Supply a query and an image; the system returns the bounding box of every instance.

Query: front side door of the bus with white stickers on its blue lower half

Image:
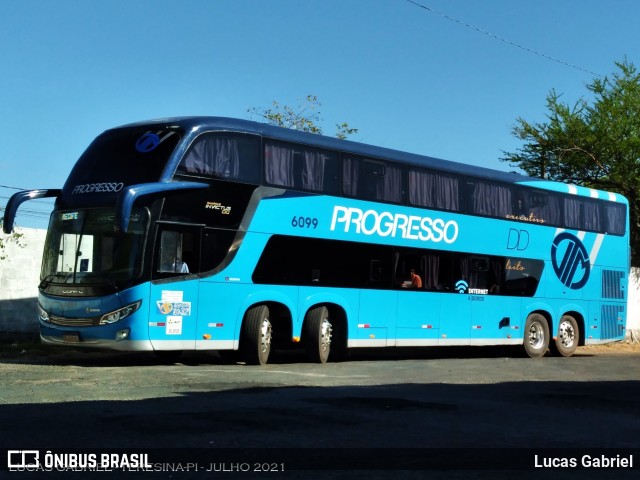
[149,224,201,350]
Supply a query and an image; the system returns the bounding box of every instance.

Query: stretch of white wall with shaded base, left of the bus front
[0,228,46,338]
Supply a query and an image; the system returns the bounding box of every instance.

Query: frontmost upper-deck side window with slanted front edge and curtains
[178,133,260,183]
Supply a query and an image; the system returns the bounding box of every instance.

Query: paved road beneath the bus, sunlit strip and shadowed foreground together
[0,348,640,480]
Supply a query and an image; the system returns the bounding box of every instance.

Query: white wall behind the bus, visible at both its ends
[0,228,640,340]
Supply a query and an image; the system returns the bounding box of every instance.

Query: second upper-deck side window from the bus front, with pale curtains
[264,140,338,194]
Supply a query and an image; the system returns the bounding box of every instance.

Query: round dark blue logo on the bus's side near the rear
[551,232,591,290]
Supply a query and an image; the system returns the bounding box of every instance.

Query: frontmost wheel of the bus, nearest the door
[240,305,273,365]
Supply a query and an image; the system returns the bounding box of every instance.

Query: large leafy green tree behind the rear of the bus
[502,60,640,266]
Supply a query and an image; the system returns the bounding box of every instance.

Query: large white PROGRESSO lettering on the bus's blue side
[331,206,458,243]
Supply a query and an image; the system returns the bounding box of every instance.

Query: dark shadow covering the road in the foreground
[0,381,640,458]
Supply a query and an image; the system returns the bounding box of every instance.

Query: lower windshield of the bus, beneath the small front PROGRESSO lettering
[41,208,149,290]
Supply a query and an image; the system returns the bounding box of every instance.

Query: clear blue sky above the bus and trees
[0,0,640,228]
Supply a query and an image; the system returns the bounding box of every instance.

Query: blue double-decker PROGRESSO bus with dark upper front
[4,117,630,364]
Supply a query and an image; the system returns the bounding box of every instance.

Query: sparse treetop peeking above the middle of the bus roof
[247,95,358,140]
